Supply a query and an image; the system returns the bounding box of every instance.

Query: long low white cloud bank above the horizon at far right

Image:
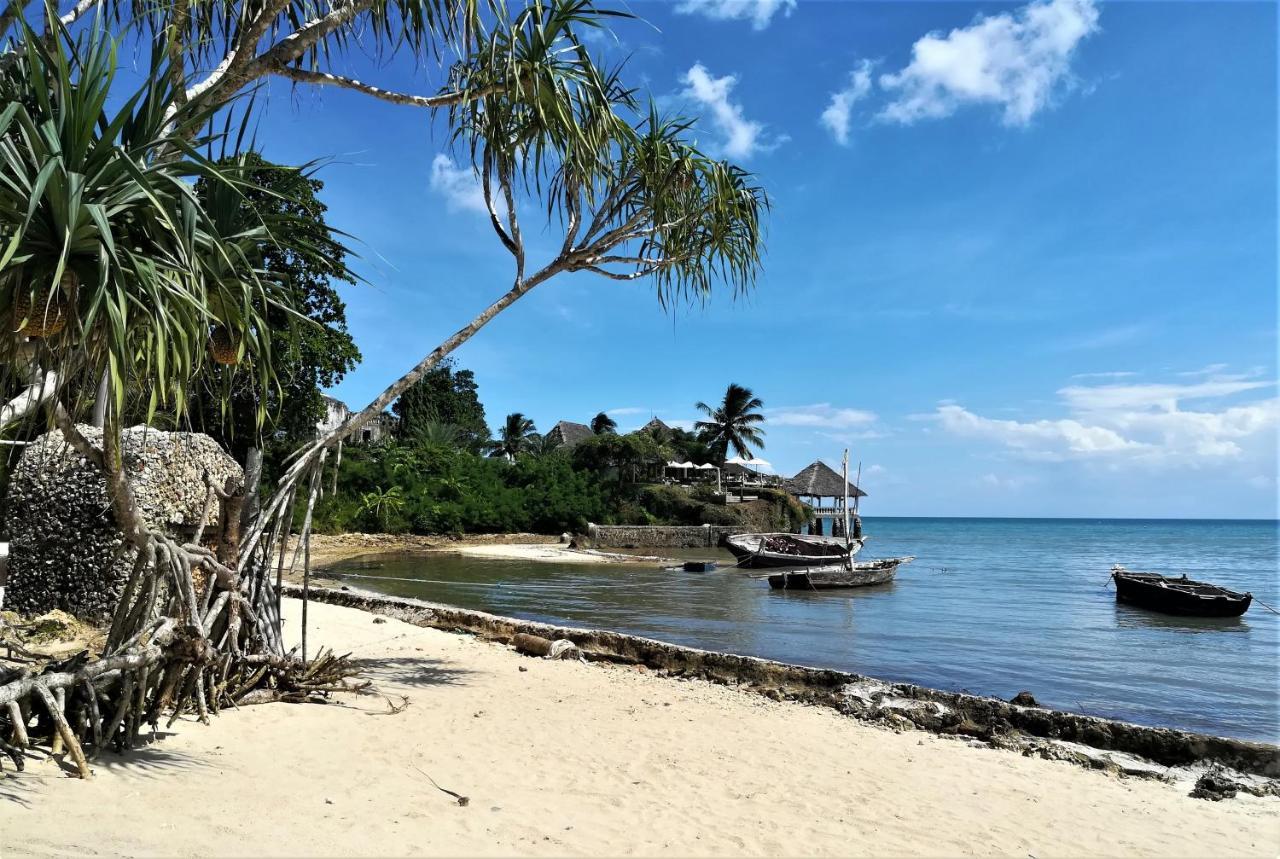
[932,368,1280,466]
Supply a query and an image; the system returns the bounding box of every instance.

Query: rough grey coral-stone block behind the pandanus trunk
[5,426,244,621]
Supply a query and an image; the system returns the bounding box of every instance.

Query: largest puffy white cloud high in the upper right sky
[879,0,1098,125]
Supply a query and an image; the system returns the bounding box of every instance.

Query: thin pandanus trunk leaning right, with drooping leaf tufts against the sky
[253,32,768,604]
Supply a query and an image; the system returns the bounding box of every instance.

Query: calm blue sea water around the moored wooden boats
[322,517,1280,743]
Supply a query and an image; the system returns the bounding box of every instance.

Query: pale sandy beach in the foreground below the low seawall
[0,600,1280,859]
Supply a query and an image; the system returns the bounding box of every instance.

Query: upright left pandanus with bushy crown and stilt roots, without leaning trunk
[0,22,355,775]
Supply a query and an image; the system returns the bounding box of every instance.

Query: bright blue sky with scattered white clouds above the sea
[235,0,1280,518]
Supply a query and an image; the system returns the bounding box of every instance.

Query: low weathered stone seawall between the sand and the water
[287,586,1280,799]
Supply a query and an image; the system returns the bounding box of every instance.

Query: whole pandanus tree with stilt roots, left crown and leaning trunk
[0,0,767,773]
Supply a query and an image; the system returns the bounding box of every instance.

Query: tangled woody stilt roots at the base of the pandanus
[0,406,369,777]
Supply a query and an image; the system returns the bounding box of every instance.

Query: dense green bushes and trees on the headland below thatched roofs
[315,378,806,534]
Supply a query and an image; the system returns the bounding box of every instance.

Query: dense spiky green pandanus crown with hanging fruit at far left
[0,24,302,430]
